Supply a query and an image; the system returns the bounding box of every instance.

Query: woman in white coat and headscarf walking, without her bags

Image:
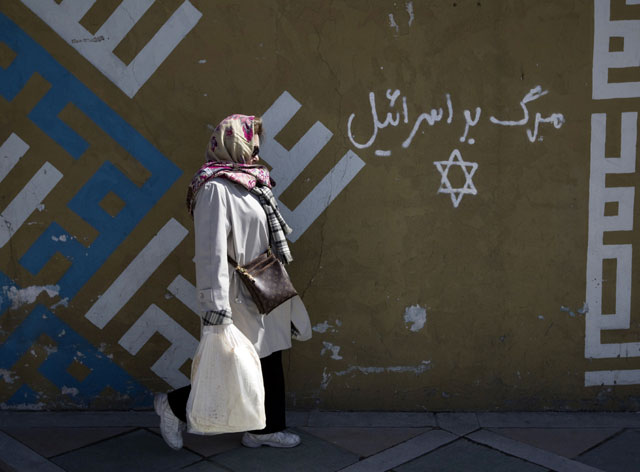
[154,115,311,449]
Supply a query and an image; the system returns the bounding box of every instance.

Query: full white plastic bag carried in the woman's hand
[187,324,266,434]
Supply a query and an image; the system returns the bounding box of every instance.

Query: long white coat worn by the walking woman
[193,178,311,358]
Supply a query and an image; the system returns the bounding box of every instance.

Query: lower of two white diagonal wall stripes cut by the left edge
[0,162,62,247]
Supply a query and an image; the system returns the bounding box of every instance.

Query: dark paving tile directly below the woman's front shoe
[210,430,358,472]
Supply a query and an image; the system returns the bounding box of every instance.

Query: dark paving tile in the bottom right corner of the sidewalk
[576,431,640,472]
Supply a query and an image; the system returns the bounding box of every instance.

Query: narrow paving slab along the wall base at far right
[476,412,640,428]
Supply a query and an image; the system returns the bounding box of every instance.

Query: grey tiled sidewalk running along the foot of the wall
[0,411,640,472]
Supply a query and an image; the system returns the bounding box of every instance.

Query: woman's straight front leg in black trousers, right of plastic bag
[251,351,287,434]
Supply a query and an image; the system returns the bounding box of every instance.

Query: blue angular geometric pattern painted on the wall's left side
[0,14,182,406]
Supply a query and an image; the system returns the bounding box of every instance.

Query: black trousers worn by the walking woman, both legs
[167,351,287,434]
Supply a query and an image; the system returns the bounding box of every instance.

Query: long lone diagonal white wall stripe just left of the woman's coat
[84,218,188,329]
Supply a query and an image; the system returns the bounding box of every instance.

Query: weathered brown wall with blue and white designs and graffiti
[0,0,640,410]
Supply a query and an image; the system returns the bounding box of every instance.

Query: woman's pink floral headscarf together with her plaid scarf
[187,115,293,264]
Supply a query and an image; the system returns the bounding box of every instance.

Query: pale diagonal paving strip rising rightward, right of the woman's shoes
[341,430,458,472]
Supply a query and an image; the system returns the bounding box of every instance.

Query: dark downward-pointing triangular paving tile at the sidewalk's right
[491,428,620,458]
